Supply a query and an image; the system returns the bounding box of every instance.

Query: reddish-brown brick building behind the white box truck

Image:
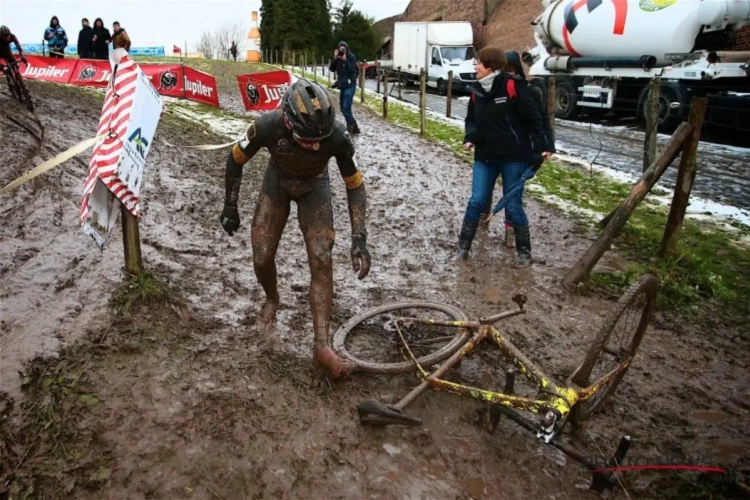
[376,0,750,55]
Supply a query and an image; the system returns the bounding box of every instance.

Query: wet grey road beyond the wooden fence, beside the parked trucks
[367,80,750,209]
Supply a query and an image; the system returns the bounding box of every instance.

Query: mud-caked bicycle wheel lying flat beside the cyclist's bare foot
[333,301,471,374]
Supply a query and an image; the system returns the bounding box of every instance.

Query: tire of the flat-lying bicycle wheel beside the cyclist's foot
[333,300,471,374]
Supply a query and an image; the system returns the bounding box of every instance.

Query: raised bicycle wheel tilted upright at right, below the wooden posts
[570,274,658,426]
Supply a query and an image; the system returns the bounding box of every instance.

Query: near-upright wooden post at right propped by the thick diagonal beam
[659,97,708,257]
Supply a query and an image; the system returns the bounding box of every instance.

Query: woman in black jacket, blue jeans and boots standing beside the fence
[457,47,550,267]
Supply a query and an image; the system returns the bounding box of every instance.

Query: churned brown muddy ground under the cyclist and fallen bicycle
[0,67,750,499]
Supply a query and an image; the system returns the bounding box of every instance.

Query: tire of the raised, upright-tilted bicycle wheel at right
[570,274,659,427]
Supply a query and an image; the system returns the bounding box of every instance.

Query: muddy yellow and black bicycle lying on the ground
[333,274,658,491]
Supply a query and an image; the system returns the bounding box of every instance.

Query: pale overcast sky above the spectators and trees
[0,0,409,52]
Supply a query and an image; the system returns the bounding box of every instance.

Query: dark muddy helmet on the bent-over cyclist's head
[282,78,336,141]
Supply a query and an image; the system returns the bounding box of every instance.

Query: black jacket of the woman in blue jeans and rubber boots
[464,73,547,164]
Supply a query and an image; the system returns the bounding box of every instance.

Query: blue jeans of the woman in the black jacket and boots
[464,160,529,227]
